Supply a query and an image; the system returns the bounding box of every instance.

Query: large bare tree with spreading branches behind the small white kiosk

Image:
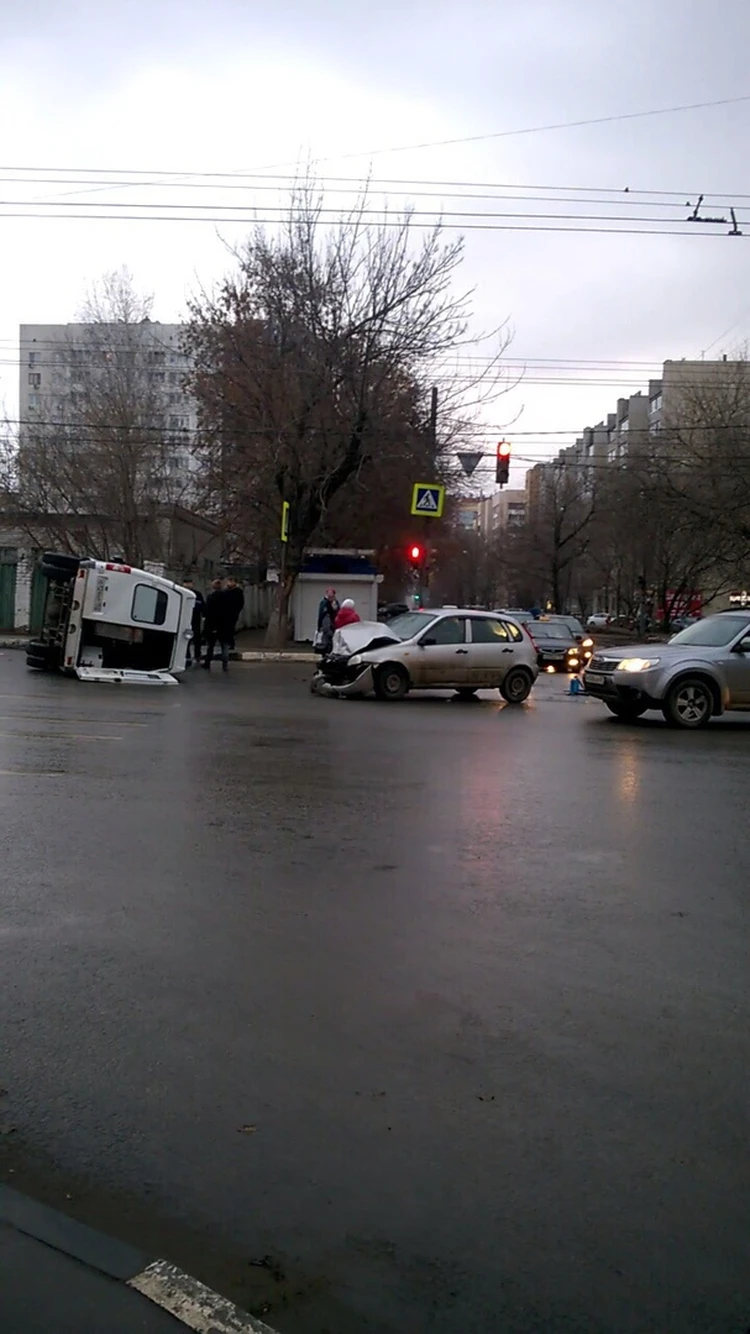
[187,184,507,638]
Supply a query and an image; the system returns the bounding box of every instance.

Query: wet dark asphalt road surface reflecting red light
[0,652,750,1334]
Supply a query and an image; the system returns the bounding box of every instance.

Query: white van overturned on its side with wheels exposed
[27,551,195,686]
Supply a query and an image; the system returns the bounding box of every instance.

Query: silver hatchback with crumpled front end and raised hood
[311,607,539,704]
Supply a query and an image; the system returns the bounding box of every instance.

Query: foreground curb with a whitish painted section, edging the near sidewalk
[0,1186,276,1334]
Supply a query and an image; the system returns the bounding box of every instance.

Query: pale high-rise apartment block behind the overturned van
[19,320,198,500]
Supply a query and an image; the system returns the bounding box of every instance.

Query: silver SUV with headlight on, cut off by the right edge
[583,611,750,727]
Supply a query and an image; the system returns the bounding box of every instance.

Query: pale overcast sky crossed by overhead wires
[0,0,750,480]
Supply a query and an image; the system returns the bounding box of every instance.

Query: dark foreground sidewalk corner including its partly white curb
[0,1186,274,1334]
